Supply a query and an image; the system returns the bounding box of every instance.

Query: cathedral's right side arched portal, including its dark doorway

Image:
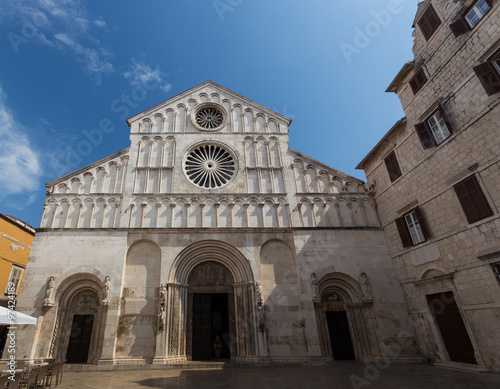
[314,273,377,360]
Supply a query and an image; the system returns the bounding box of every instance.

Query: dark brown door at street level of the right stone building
[426,292,477,365]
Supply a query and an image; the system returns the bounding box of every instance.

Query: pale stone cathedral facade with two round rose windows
[13,81,421,365]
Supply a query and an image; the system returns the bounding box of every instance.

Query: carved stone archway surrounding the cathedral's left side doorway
[49,274,107,364]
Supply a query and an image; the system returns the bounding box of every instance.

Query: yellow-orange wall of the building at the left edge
[0,215,35,306]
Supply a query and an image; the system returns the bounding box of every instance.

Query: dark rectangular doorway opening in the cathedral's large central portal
[192,293,230,361]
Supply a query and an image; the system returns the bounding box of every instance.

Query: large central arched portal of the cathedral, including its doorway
[166,240,259,362]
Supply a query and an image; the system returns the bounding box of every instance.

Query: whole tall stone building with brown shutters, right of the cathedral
[358,0,500,371]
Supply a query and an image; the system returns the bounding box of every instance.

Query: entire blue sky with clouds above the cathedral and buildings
[0,0,417,227]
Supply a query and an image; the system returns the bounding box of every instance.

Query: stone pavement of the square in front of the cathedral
[54,362,500,389]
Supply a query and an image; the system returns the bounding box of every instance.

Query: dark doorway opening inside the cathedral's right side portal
[326,311,355,360]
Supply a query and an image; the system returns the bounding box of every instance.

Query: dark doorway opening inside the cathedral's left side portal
[66,315,94,363]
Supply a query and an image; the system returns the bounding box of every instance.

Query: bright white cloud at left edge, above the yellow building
[0,87,42,197]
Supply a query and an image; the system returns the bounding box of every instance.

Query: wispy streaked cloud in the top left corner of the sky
[0,0,113,83]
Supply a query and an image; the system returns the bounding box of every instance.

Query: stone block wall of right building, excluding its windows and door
[363,1,500,371]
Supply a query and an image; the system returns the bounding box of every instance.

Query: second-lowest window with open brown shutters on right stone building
[415,105,452,150]
